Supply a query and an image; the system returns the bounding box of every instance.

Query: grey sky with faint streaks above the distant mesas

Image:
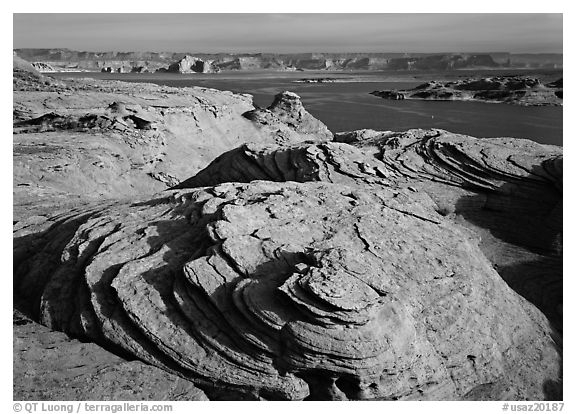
[13,13,563,53]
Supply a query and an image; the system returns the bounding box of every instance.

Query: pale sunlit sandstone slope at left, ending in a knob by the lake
[13,62,331,217]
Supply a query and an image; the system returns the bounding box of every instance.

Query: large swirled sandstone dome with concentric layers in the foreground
[14,181,560,399]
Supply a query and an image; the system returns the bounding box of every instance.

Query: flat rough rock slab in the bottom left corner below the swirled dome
[13,311,208,401]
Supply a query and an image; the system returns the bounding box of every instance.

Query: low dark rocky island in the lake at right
[371,76,562,105]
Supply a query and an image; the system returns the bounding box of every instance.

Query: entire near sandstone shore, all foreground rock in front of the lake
[13,53,563,400]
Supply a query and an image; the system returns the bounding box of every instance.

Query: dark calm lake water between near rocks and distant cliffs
[56,71,563,145]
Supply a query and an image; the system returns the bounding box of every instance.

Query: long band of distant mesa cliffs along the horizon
[15,49,563,73]
